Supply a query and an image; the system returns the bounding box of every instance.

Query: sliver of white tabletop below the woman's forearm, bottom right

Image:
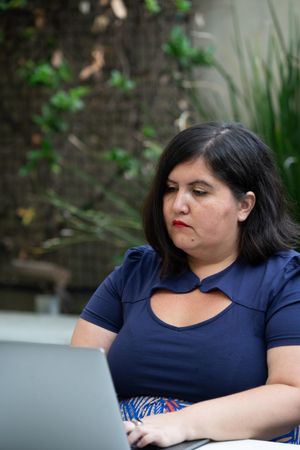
[206,439,298,450]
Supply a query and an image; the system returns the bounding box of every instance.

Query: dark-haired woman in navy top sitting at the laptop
[72,122,300,447]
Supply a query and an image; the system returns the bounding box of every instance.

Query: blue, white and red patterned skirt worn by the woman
[119,396,300,445]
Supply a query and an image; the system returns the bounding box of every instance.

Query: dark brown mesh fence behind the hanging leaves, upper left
[0,0,187,306]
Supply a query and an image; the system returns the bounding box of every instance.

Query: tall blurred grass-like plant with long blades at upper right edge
[239,2,300,211]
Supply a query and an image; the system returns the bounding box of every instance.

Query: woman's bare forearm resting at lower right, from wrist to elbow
[178,384,300,441]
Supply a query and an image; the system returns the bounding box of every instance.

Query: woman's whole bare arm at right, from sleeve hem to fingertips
[127,346,300,447]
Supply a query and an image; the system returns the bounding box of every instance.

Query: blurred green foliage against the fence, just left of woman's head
[43,125,162,252]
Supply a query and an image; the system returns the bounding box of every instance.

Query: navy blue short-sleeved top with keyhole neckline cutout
[81,246,300,402]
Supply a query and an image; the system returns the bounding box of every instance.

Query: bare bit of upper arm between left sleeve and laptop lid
[71,319,117,353]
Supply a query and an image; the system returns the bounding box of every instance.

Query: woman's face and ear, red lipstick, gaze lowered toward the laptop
[163,158,255,261]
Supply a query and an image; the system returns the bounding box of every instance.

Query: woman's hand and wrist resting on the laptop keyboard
[124,411,186,448]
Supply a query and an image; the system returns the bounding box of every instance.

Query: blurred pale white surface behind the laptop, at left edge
[0,311,78,344]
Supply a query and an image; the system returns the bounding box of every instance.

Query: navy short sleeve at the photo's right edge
[266,256,300,349]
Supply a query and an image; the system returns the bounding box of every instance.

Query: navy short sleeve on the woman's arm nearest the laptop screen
[80,246,148,333]
